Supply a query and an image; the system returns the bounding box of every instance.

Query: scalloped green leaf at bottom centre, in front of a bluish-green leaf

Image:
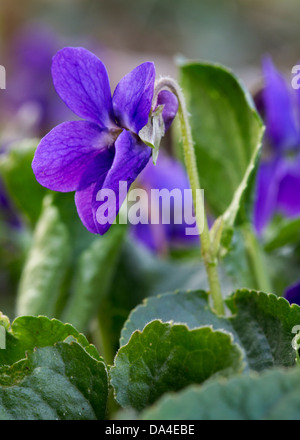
[110,320,243,410]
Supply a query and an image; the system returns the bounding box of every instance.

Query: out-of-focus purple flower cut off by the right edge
[254,58,300,234]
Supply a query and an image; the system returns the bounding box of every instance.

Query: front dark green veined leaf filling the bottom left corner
[0,342,108,420]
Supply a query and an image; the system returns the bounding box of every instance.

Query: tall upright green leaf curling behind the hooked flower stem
[180,62,263,248]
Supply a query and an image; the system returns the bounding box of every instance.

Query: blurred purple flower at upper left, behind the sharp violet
[3,25,71,140]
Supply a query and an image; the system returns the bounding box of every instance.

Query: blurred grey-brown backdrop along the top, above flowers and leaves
[0,0,300,88]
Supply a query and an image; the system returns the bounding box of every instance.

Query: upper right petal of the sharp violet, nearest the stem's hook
[113,62,155,134]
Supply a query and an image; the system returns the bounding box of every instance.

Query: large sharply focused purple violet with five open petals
[32,47,177,234]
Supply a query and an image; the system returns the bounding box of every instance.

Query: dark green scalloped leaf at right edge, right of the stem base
[227,289,300,371]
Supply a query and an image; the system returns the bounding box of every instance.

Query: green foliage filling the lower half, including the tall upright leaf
[0,56,300,420]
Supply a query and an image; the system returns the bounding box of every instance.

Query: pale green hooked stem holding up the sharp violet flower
[153,78,225,315]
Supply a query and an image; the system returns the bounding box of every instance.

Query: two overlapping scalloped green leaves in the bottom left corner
[0,316,108,420]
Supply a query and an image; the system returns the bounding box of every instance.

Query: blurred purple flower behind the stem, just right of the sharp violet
[131,152,199,254]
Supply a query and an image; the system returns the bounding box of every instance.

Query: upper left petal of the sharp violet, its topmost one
[52,47,115,128]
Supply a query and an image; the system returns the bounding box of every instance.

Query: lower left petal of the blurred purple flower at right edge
[253,159,282,235]
